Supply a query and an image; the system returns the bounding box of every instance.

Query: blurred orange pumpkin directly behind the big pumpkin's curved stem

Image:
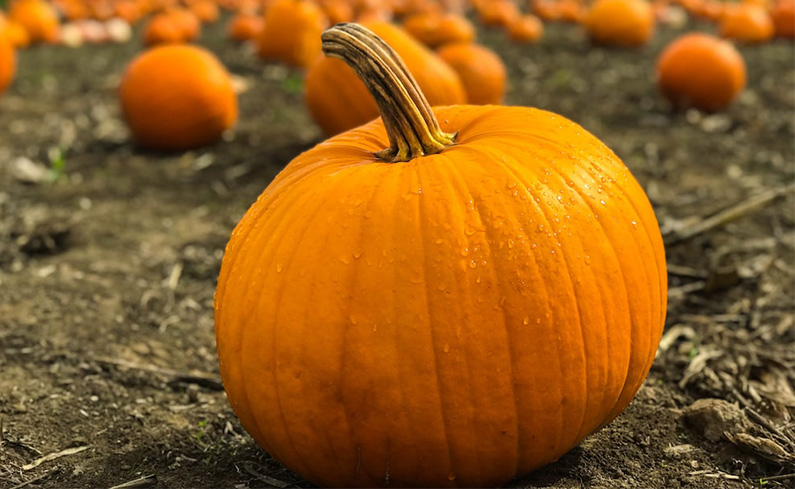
[305,21,466,135]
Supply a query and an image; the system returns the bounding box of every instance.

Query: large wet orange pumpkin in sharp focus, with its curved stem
[215,24,667,487]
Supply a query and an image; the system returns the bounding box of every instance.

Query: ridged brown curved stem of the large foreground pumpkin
[321,24,457,163]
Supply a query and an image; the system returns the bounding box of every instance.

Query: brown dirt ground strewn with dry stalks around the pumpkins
[0,14,795,489]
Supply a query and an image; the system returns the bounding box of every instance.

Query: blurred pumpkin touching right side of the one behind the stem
[436,43,508,105]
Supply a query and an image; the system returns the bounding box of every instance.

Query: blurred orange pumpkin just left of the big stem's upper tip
[258,0,327,67]
